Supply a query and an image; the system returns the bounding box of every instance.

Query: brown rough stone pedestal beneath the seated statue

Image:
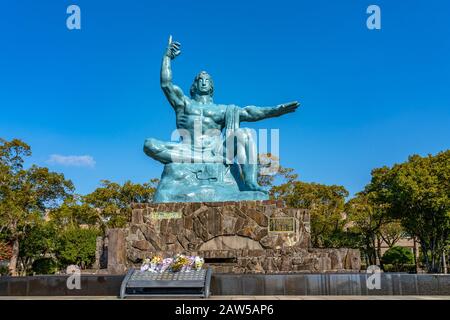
[121,200,360,273]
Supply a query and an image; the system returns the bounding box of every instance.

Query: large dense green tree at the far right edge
[366,150,450,272]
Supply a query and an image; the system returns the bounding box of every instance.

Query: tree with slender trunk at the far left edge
[0,139,73,275]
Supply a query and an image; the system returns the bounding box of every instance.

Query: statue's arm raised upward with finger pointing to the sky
[161,36,186,109]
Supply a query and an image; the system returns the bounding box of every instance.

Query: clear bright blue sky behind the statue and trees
[0,0,450,194]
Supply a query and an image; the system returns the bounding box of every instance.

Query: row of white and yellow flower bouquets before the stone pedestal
[141,254,205,272]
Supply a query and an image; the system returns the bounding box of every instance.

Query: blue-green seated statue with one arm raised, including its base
[144,37,299,203]
